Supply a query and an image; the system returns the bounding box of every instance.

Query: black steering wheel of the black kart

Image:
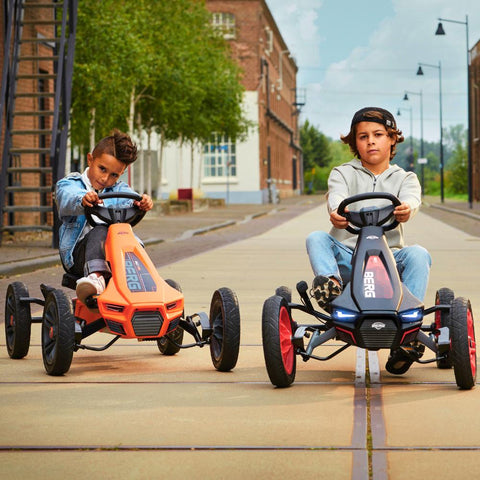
[337,192,402,235]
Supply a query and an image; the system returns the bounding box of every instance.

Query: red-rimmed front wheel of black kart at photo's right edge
[450,297,477,390]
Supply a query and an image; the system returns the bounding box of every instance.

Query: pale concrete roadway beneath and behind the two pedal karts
[0,199,480,480]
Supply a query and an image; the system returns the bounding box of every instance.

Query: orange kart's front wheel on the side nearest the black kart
[209,287,240,372]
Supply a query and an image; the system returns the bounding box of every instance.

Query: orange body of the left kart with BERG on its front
[75,223,184,340]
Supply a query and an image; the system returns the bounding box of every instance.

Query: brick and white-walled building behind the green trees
[140,0,303,203]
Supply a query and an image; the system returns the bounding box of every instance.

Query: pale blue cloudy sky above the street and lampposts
[266,0,480,142]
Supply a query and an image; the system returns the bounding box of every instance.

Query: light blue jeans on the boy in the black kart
[307,231,432,301]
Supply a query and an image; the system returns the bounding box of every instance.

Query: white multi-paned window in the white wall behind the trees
[203,134,237,178]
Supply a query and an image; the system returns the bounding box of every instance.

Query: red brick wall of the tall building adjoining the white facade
[206,0,301,196]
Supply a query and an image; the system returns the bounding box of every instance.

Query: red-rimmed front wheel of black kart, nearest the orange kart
[262,295,297,387]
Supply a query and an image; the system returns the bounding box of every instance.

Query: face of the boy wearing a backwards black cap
[355,122,395,174]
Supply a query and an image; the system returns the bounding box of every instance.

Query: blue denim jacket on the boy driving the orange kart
[55,172,133,270]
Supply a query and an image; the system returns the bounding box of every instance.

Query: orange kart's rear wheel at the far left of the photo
[5,282,32,358]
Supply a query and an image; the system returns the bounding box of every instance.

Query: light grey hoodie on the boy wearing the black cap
[327,159,422,250]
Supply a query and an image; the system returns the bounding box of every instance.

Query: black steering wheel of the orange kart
[85,192,147,227]
